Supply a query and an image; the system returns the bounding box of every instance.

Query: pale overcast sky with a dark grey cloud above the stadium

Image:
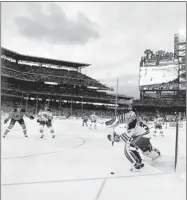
[1,2,186,98]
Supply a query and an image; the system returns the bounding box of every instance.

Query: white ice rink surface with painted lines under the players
[1,119,186,200]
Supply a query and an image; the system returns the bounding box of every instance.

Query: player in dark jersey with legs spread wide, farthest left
[3,105,34,138]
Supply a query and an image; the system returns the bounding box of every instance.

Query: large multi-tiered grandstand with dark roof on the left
[1,48,132,116]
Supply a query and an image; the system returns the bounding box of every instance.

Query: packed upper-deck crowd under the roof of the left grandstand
[1,59,107,88]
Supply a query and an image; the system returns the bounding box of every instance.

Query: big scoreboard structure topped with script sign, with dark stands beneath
[132,35,186,117]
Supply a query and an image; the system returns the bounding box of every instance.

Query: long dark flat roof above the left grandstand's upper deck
[1,47,91,69]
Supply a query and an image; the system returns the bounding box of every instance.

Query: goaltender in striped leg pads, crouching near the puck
[105,111,160,171]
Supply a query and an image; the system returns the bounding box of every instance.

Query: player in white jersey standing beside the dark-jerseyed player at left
[37,105,55,138]
